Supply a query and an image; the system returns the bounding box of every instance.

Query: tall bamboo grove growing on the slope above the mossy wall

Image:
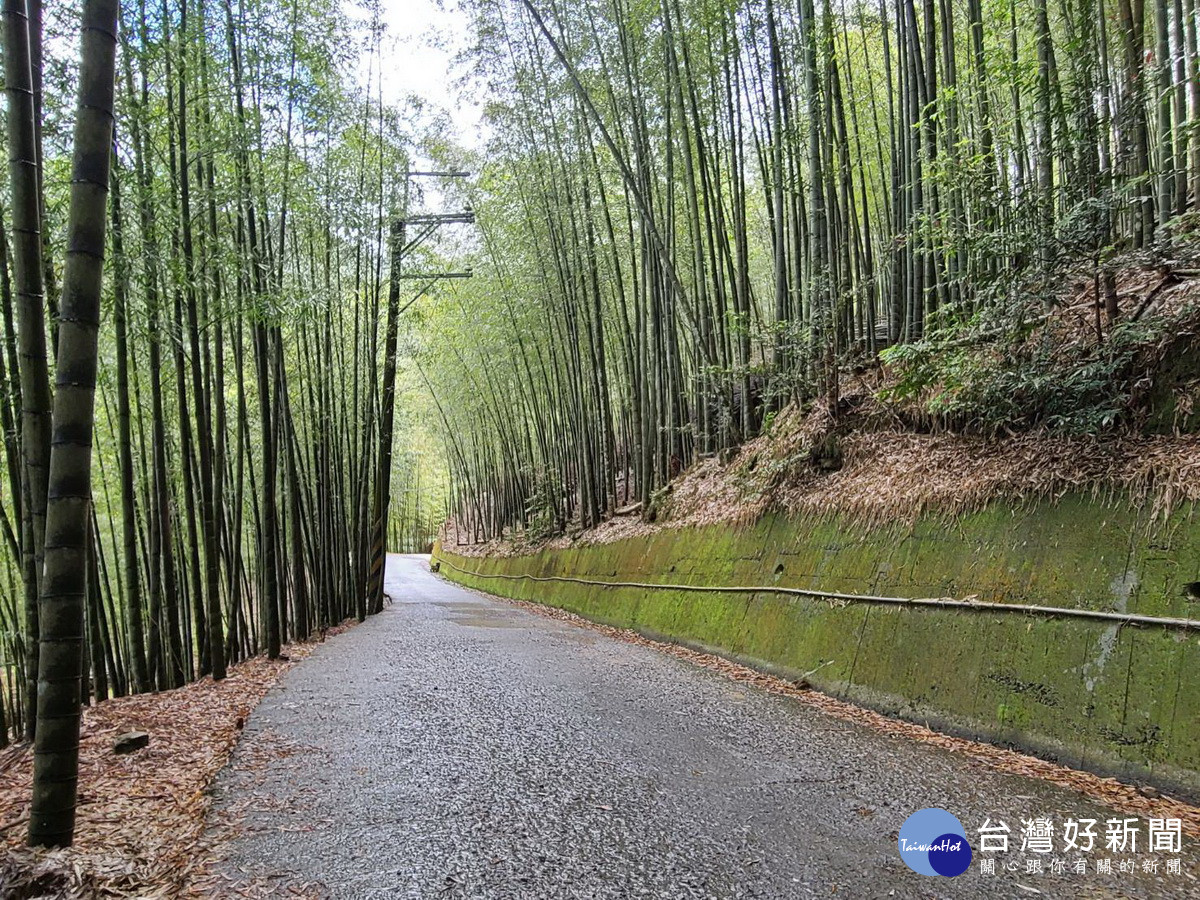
[422,0,1200,541]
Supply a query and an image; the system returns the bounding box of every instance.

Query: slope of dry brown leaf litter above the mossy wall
[443,260,1200,557]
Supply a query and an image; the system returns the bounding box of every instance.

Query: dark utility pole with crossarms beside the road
[367,170,475,612]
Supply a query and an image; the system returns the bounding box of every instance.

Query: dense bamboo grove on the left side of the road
[0,0,444,845]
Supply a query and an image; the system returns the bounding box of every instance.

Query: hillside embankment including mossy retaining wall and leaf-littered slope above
[434,267,1200,798]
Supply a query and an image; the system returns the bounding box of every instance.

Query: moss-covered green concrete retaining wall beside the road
[434,497,1200,796]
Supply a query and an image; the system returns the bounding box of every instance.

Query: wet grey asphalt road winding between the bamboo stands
[212,557,1200,899]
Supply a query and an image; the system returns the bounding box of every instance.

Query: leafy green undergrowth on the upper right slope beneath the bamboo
[876,262,1200,434]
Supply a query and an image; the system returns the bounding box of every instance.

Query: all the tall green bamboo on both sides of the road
[0,0,1200,845]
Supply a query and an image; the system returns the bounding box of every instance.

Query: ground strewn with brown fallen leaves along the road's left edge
[0,623,349,900]
